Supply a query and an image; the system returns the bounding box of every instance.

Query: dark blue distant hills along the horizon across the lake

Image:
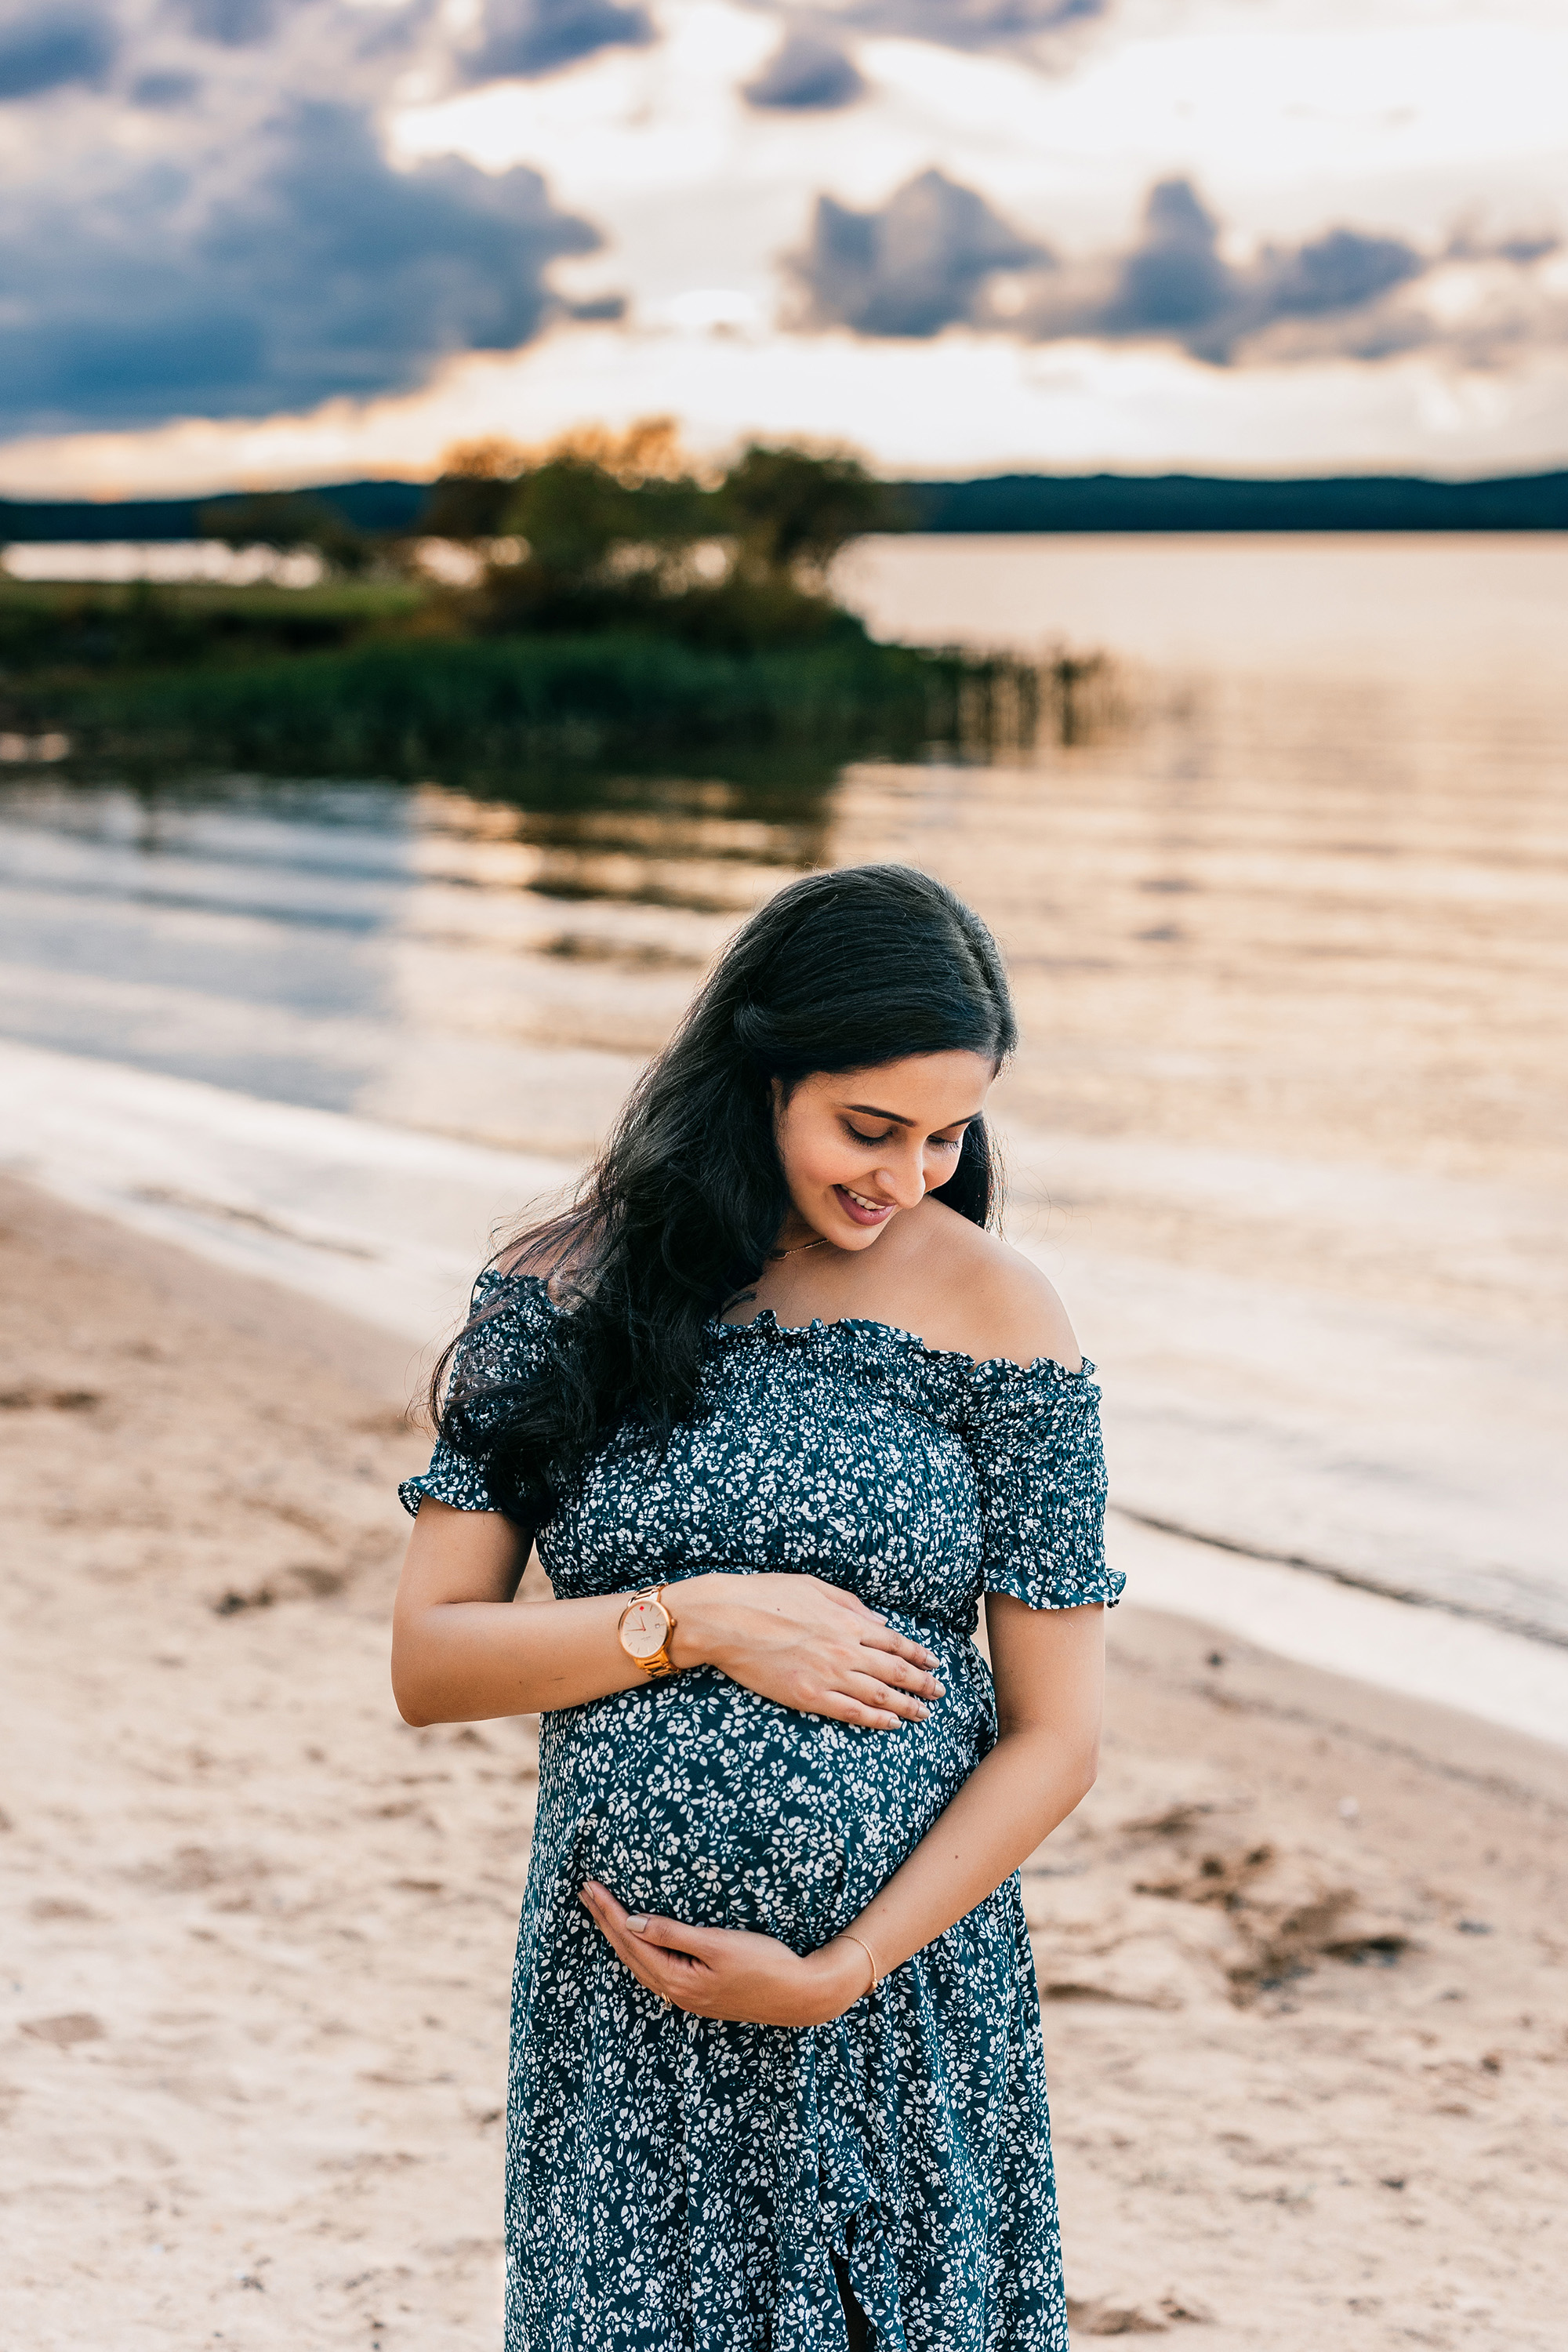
[0,473,1568,546]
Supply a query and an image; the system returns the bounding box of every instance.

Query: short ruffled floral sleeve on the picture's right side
[966,1357,1126,1609]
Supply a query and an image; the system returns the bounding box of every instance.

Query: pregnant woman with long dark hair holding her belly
[393,866,1119,2352]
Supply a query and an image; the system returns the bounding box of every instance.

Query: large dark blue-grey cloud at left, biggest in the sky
[0,103,600,433]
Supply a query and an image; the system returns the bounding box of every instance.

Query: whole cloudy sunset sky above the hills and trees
[0,0,1568,494]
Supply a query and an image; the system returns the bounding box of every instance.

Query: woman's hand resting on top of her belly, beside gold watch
[666,1571,942,1731]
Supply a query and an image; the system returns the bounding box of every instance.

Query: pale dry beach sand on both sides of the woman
[0,1185,1568,2352]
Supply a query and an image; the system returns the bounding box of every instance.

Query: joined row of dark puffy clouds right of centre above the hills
[789,172,1504,367]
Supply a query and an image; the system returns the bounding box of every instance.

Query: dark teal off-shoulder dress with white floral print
[405,1270,1121,2352]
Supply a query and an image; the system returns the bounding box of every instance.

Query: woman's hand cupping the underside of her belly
[583,1879,869,2027]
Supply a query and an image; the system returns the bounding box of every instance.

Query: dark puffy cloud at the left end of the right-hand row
[792,172,1048,334]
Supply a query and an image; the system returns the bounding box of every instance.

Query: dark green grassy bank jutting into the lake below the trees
[0,583,1034,774]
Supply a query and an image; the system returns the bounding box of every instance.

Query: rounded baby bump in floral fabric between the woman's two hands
[550,1637,989,1952]
